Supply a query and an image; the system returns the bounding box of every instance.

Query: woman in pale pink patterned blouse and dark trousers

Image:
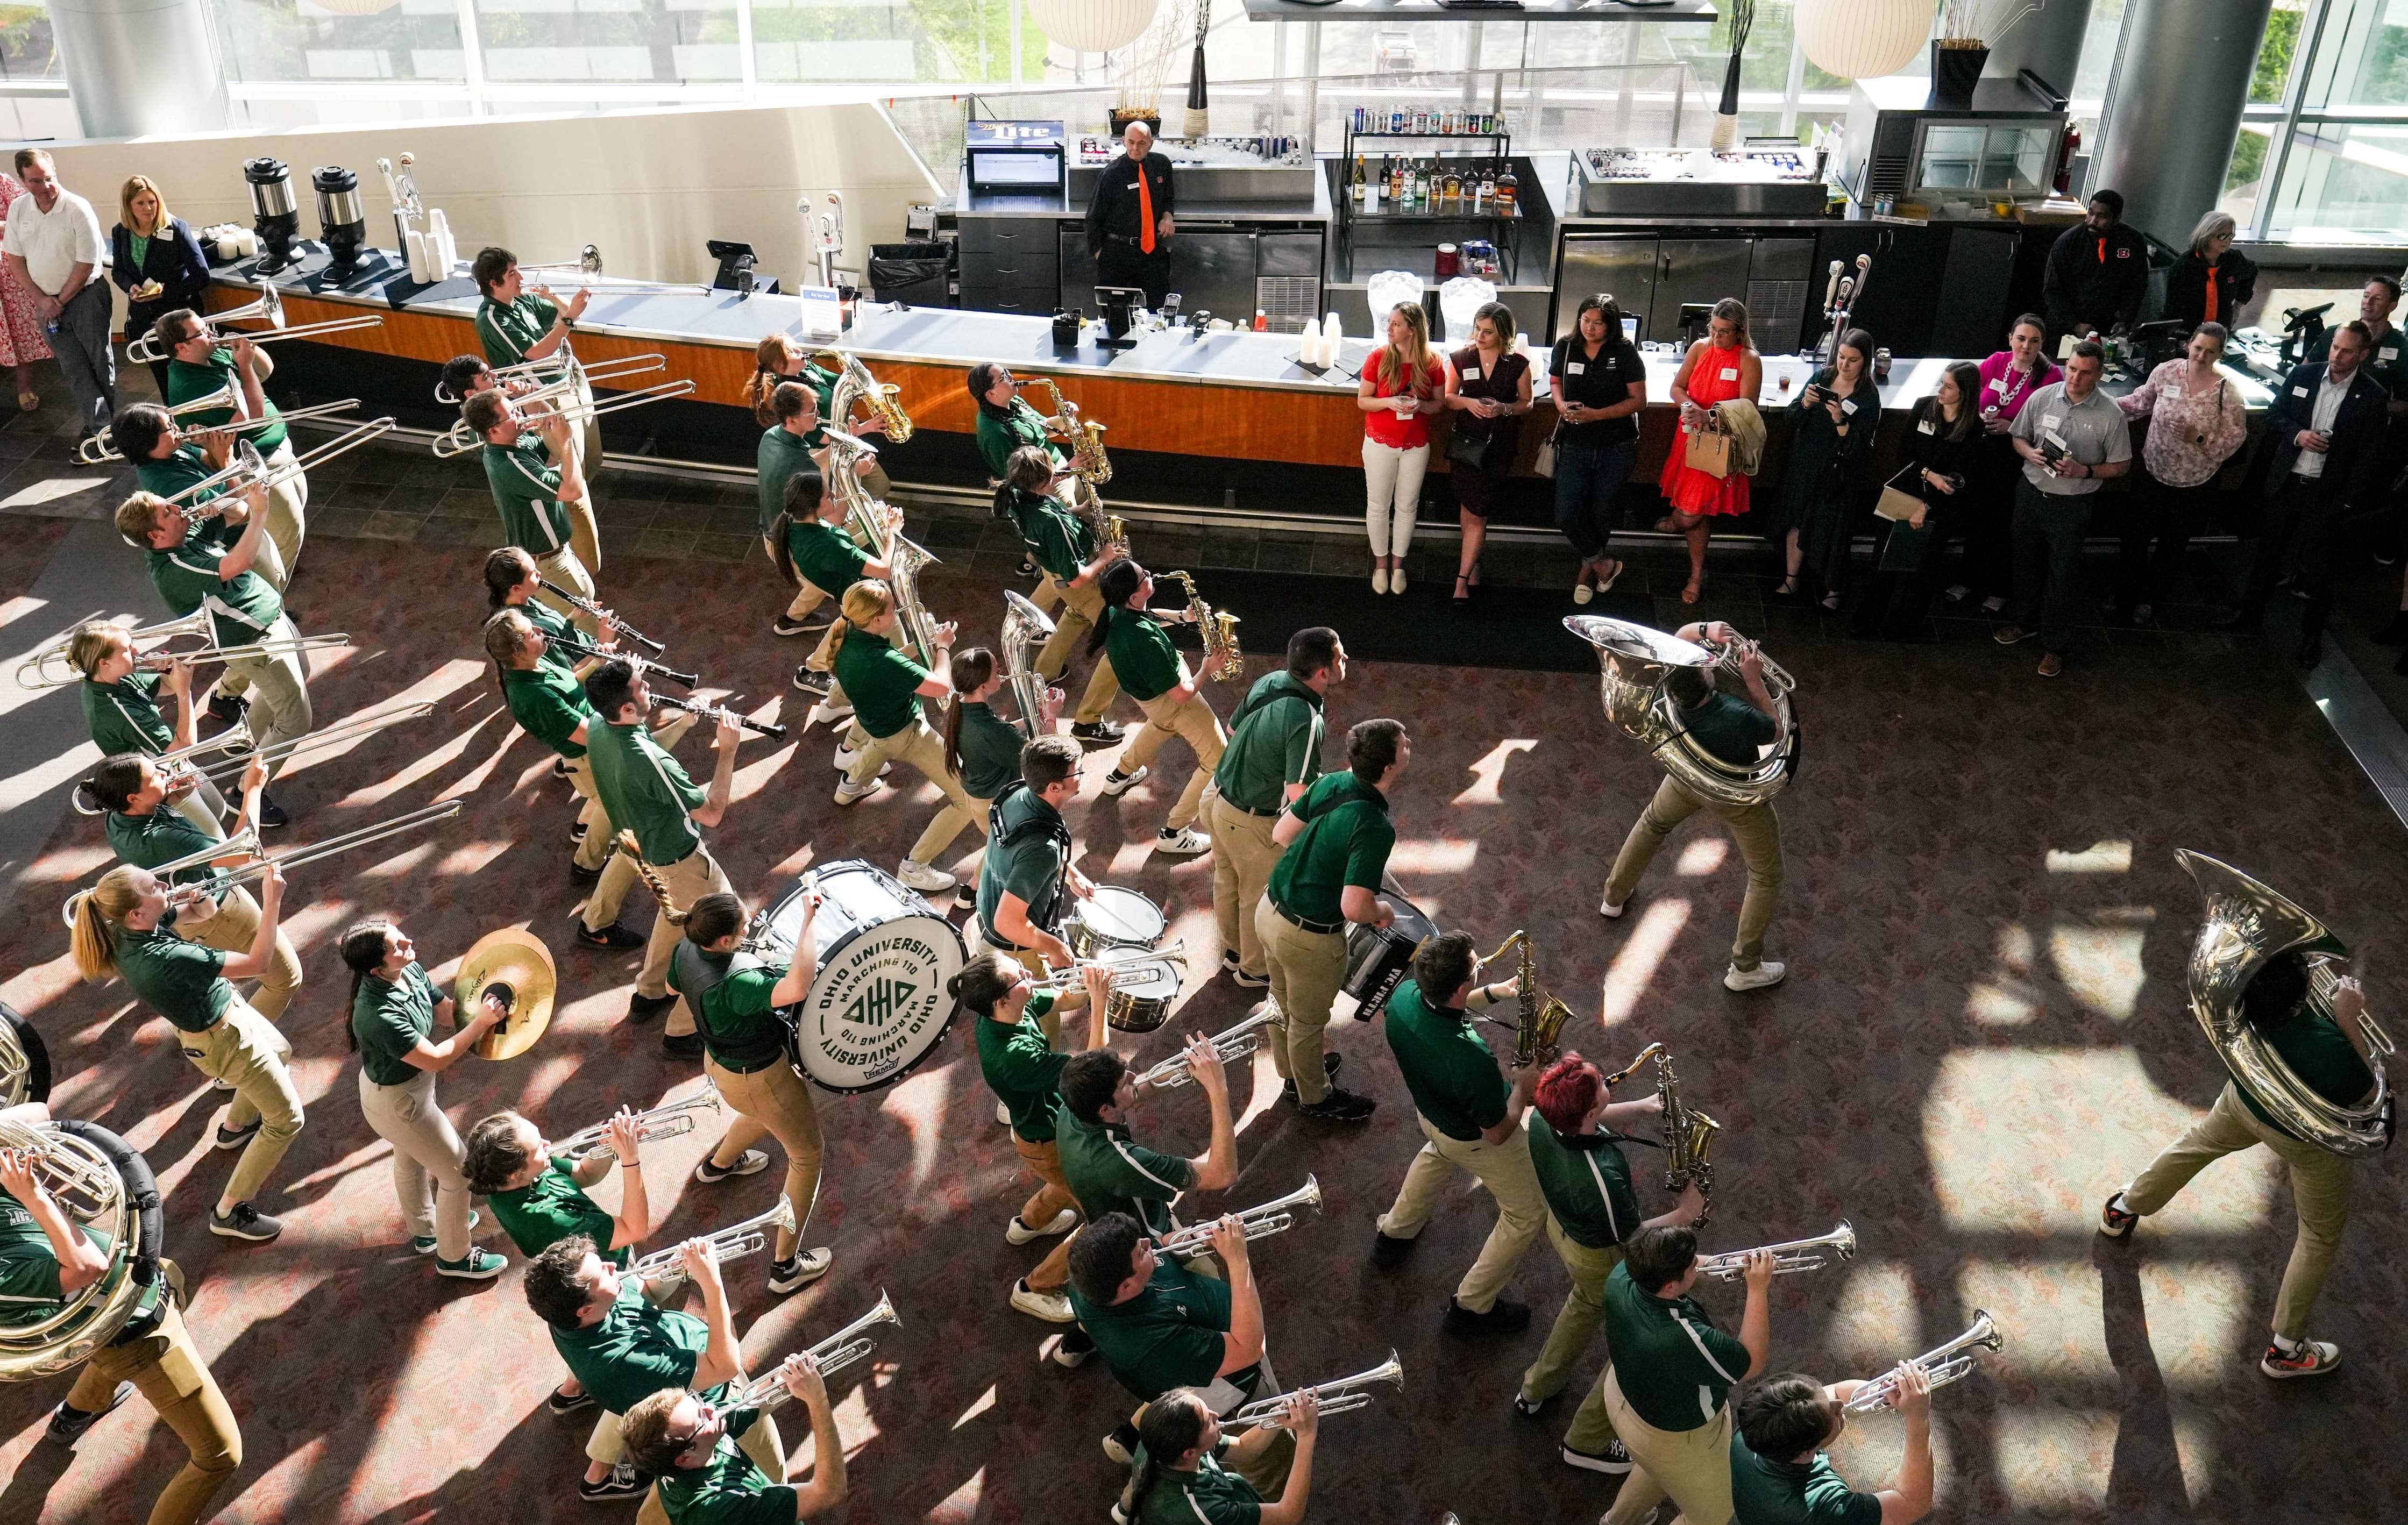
[2114,323,2249,624]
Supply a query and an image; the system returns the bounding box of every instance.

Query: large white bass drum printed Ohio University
[747,858,965,1092]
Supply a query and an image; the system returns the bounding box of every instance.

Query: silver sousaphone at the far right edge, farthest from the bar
[2175,848,2398,1159]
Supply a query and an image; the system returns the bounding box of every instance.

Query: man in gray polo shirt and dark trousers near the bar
[1991,340,2131,677]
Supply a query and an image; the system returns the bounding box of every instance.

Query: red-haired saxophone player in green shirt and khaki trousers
[1512,1053,1705,1472]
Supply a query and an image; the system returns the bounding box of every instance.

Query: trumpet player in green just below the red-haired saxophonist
[1572,1229,1775,1525]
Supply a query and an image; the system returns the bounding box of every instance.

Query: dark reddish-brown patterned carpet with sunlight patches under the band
[0,505,2408,1525]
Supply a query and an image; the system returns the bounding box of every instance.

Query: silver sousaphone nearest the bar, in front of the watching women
[1563,614,1799,804]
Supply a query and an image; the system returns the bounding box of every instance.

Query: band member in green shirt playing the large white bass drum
[670,892,833,1296]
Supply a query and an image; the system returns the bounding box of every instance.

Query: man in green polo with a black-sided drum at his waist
[1255,721,1413,1123]
